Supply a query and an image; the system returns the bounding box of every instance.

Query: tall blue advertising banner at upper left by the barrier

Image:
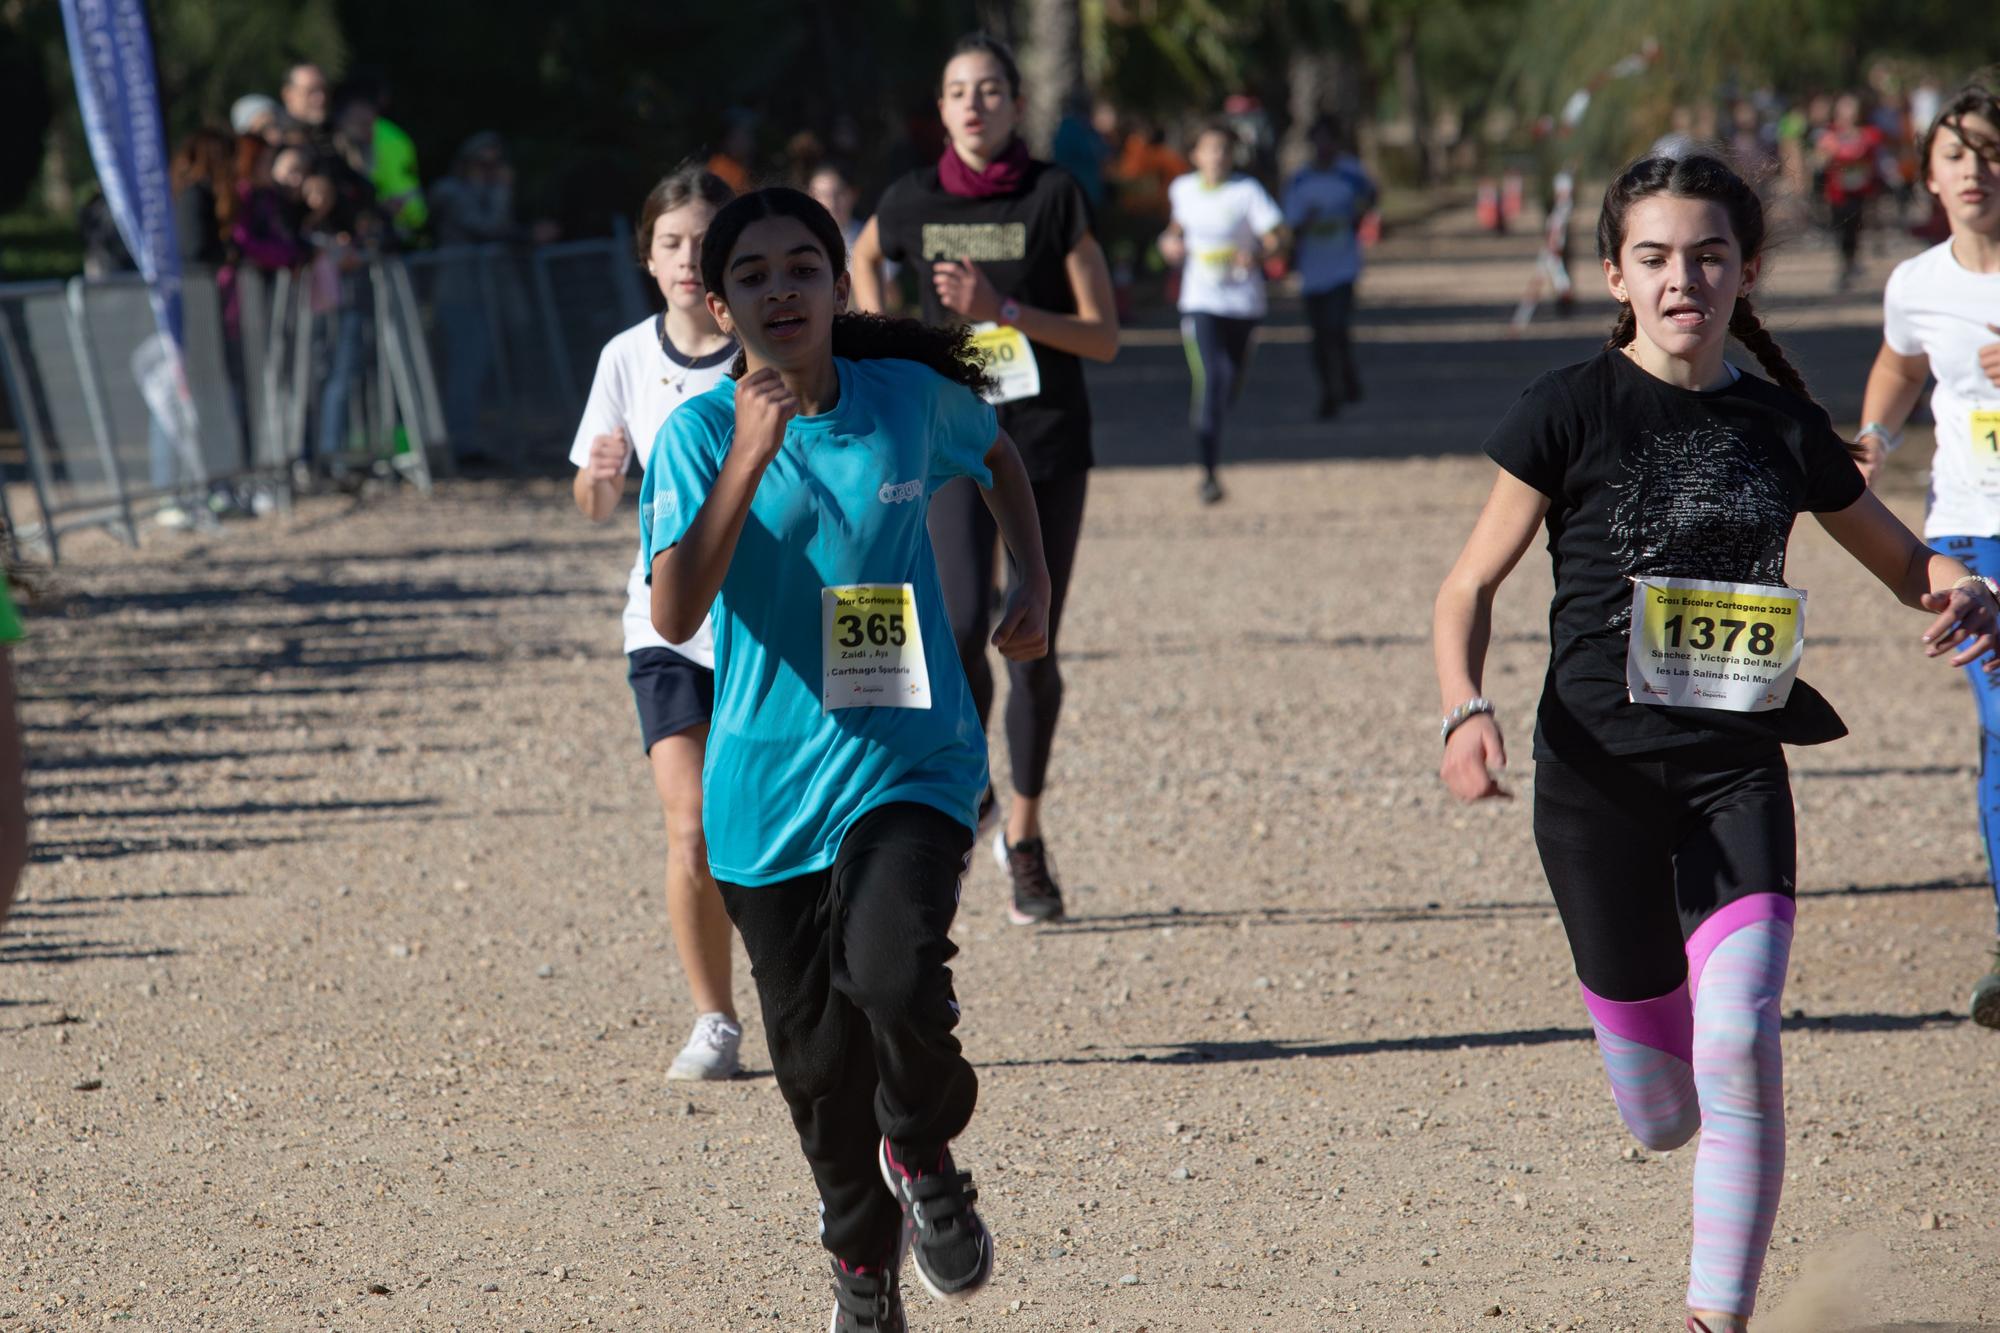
[62,0,182,352]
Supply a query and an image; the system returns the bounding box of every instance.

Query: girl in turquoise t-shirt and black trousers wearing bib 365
[640,190,1050,1333]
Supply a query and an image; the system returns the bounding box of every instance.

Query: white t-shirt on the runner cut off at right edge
[1882,240,2000,538]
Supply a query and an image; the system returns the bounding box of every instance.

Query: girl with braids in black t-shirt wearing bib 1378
[1434,156,2000,1333]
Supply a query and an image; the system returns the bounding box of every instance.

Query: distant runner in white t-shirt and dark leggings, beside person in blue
[1160,124,1284,504]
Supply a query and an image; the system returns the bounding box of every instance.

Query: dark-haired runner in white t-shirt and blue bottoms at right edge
[1856,84,2000,1029]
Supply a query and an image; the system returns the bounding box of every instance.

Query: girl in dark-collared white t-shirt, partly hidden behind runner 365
[570,166,742,1079]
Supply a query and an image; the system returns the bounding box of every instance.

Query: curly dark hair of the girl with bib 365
[702,186,992,394]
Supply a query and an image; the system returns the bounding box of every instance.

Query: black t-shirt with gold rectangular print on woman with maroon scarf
[876,162,1092,480]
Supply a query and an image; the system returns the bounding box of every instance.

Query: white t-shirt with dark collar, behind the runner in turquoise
[570,314,736,669]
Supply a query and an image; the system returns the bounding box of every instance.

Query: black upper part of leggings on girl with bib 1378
[1534,743,1798,1003]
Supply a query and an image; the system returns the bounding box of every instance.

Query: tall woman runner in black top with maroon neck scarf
[852,34,1118,925]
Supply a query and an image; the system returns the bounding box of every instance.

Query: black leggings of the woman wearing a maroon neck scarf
[930,472,1090,797]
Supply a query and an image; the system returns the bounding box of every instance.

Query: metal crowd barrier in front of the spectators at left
[0,232,648,560]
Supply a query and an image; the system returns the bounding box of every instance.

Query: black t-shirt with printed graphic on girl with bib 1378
[1486,350,1866,759]
